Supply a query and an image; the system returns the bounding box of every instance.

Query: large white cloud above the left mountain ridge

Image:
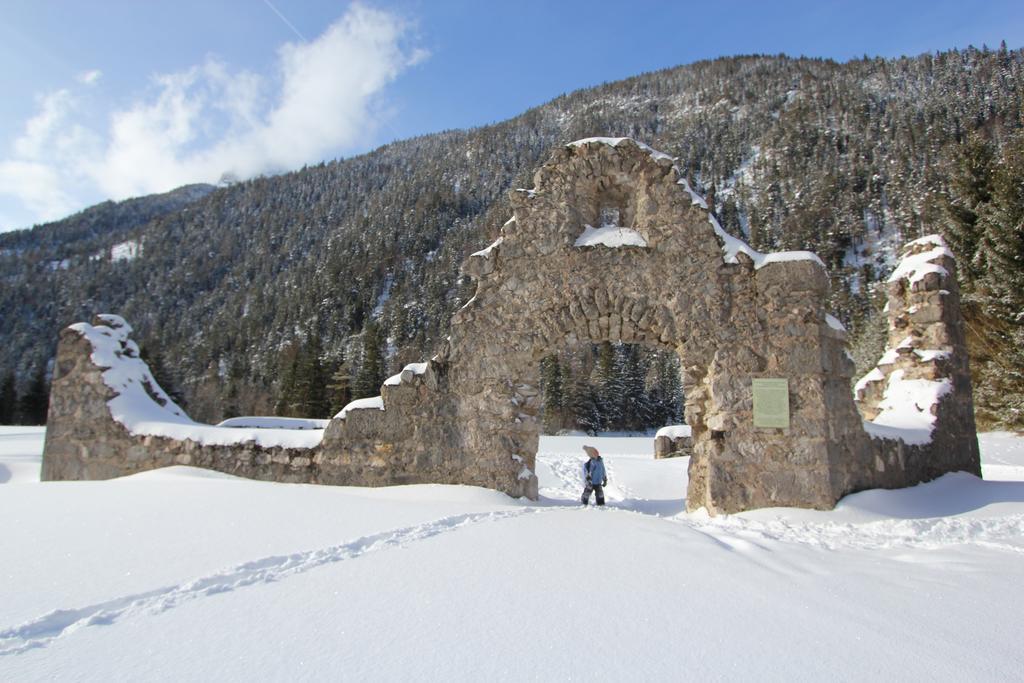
[0,4,426,229]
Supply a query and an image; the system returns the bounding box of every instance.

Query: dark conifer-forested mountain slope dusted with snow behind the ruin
[0,48,1024,420]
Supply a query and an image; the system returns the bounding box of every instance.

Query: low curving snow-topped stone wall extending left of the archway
[42,314,459,485]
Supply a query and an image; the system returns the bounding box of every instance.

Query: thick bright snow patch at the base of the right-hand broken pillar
[857,370,953,445]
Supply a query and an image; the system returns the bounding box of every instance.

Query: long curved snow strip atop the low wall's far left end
[71,313,324,449]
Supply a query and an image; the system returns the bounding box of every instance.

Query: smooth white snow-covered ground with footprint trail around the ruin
[0,427,1024,681]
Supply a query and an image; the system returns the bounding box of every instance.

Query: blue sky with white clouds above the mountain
[0,0,1024,230]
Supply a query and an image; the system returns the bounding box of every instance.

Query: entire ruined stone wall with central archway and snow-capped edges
[43,138,980,514]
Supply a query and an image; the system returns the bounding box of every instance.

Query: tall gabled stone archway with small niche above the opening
[446,139,860,510]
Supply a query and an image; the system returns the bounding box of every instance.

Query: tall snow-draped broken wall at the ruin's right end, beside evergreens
[854,234,981,485]
